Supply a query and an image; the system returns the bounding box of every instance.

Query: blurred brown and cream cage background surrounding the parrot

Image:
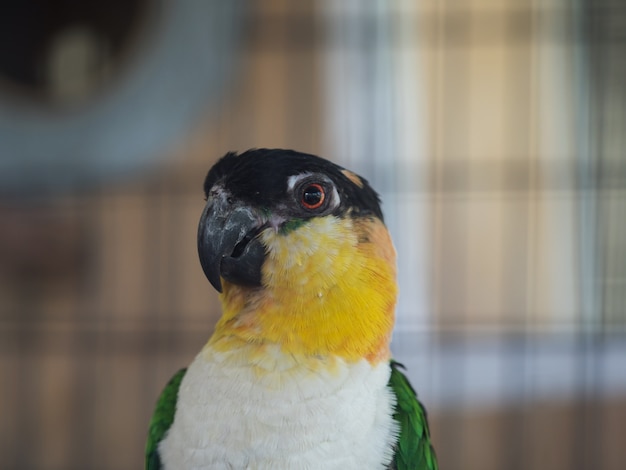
[0,0,626,470]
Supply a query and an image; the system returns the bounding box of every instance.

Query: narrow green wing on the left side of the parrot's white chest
[145,369,187,470]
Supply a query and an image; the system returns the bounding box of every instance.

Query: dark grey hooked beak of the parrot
[198,196,265,292]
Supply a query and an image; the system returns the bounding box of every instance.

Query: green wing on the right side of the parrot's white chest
[389,361,439,470]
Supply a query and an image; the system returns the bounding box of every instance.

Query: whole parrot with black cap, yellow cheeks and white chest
[145,148,438,470]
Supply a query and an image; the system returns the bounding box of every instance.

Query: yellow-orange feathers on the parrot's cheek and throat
[211,216,397,364]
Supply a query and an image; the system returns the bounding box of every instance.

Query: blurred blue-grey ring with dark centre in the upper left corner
[0,0,242,197]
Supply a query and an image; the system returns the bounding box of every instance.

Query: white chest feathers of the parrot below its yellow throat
[159,347,398,470]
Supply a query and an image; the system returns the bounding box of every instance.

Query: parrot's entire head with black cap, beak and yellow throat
[198,149,396,359]
